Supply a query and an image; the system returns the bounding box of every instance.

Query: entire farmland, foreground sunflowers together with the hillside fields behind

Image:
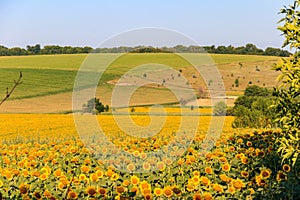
[0,53,299,199]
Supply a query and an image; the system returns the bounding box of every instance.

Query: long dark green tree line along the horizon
[0,44,291,57]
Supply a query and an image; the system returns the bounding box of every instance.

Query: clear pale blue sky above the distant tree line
[0,0,292,48]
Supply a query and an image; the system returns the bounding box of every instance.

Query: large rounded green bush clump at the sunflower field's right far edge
[232,86,274,128]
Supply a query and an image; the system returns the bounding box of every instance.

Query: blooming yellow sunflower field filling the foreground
[0,114,300,199]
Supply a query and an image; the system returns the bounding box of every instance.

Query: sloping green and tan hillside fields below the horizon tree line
[0,53,280,112]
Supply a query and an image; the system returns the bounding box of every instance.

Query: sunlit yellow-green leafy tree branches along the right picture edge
[272,0,300,165]
